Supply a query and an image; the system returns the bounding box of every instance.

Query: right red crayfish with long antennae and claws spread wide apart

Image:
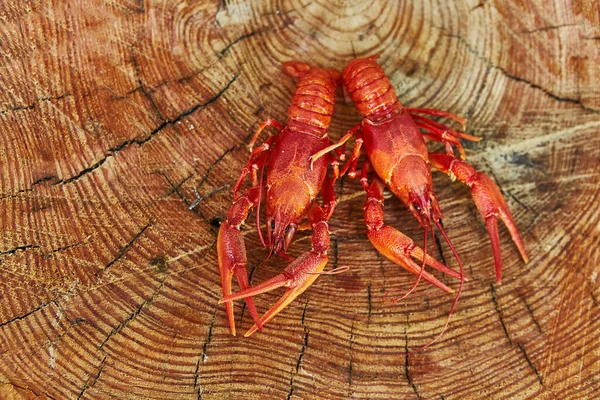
[311,56,527,345]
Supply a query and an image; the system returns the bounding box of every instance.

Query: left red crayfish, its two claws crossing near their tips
[217,61,341,336]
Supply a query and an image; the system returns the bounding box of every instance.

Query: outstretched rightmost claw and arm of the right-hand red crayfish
[429,153,529,283]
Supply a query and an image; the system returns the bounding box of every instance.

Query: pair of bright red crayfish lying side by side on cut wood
[217,57,527,345]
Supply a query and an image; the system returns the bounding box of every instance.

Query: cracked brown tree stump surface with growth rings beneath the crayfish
[0,0,600,399]
